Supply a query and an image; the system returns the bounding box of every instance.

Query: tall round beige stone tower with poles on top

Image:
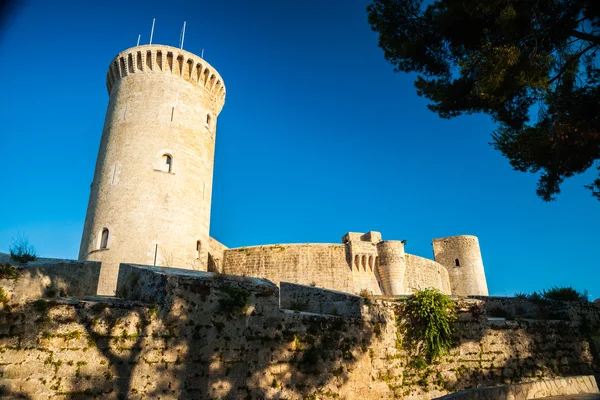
[79,45,225,295]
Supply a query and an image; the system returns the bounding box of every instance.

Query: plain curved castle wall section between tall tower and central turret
[223,244,355,293]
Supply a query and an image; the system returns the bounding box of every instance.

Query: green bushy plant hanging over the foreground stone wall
[404,289,456,361]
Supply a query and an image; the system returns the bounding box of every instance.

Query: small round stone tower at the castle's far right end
[432,235,488,296]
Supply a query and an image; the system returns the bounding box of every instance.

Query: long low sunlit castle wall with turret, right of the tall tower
[220,232,460,296]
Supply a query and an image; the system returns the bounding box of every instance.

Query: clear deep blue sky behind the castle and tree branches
[0,0,600,298]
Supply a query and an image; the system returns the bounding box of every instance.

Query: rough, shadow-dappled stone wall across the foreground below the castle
[0,258,600,399]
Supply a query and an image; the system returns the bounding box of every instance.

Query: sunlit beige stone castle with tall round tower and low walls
[79,45,488,296]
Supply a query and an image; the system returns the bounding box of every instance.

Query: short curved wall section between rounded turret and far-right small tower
[404,254,451,294]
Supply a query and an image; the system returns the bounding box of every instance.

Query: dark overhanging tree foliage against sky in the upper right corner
[367,0,600,201]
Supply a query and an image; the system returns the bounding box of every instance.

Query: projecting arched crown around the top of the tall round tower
[106,44,225,113]
